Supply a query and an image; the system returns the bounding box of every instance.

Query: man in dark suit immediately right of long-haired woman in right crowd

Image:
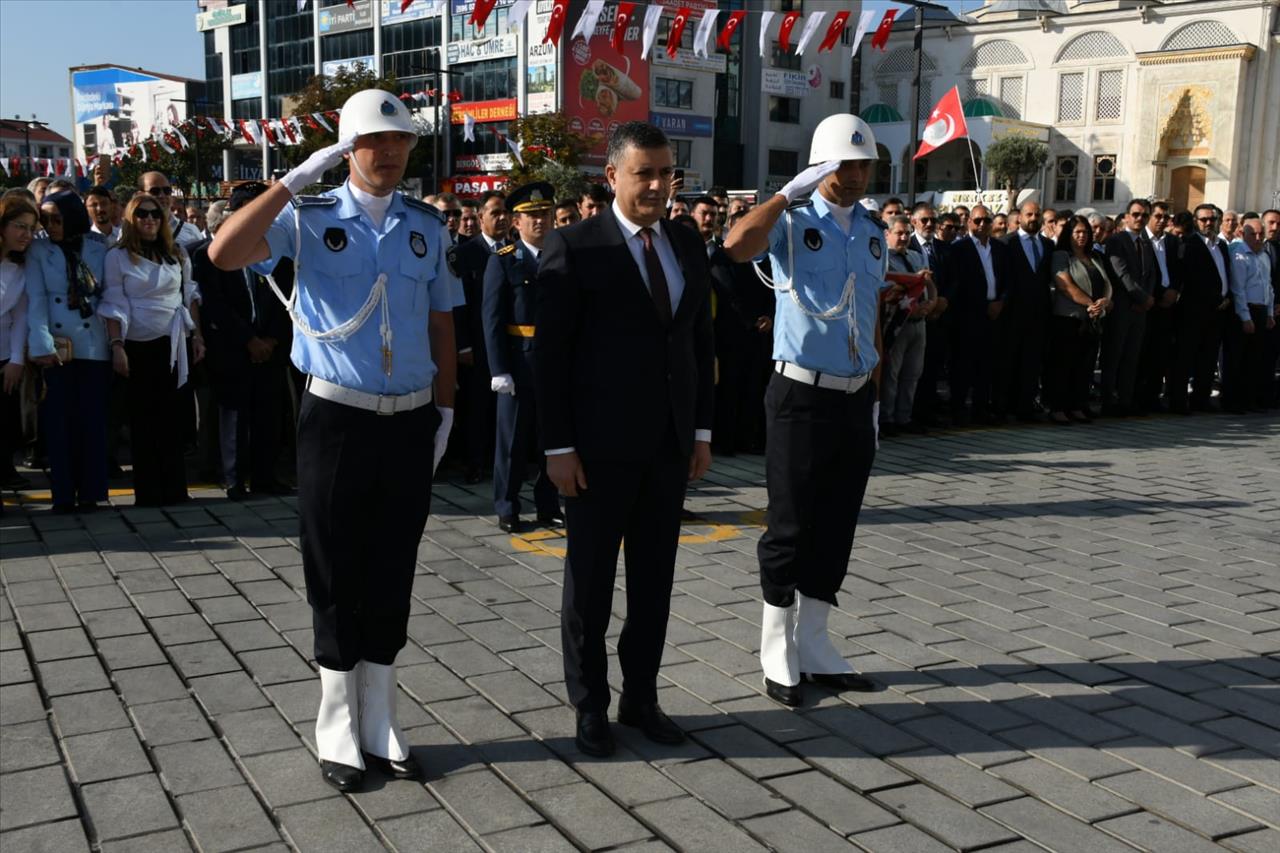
[1102,199,1160,416]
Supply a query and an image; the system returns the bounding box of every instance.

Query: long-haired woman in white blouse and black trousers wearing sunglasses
[99,195,205,506]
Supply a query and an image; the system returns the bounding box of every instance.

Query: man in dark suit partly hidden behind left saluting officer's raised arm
[192,182,293,500]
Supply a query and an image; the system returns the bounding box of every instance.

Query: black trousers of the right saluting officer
[756,374,876,607]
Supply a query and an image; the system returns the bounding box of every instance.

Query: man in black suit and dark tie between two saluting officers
[535,122,716,756]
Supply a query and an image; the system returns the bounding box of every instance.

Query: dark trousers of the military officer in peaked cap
[493,348,559,519]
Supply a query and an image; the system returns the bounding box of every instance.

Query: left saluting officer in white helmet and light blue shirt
[209,90,462,792]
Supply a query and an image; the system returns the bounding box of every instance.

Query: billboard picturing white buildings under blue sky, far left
[72,68,187,158]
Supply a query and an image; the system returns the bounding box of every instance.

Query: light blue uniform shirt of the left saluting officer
[255,183,465,394]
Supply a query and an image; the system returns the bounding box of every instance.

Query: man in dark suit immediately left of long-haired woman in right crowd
[995,201,1053,421]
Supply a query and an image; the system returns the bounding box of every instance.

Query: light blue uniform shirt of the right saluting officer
[769,192,888,377]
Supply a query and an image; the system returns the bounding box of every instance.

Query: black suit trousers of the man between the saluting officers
[561,427,689,711]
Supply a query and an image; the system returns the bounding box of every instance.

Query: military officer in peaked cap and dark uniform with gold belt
[481,182,564,533]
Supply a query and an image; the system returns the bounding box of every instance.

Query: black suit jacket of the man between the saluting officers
[535,209,716,462]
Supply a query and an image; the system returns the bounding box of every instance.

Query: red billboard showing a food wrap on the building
[563,3,649,167]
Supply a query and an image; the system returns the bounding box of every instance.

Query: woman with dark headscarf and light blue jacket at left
[26,192,111,512]
